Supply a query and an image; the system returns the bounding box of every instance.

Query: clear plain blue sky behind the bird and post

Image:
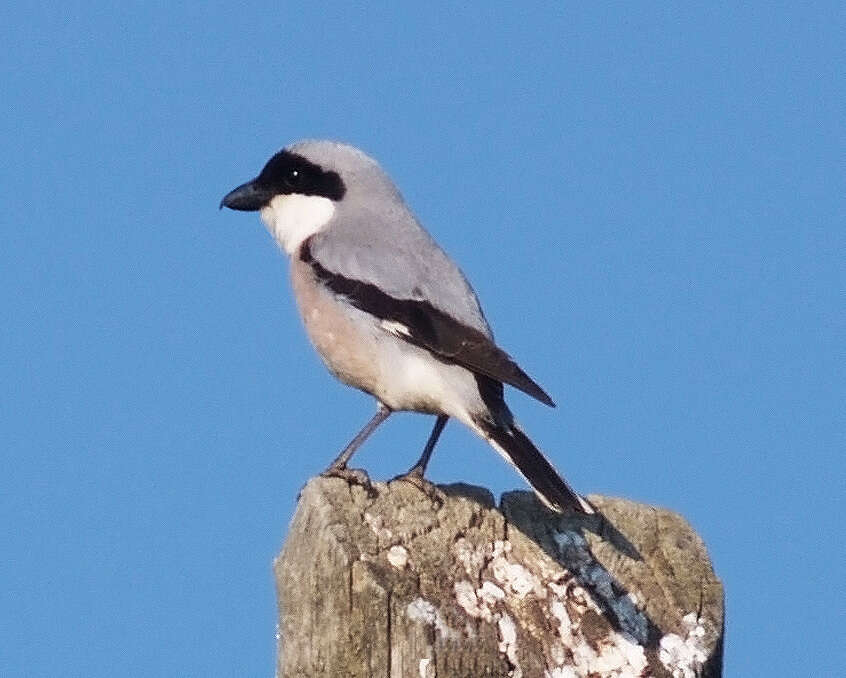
[0,2,846,678]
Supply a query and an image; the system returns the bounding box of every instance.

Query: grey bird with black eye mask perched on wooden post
[220,140,595,514]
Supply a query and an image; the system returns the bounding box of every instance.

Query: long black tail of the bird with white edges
[478,422,596,514]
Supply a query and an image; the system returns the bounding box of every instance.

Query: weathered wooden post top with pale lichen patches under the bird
[274,478,723,678]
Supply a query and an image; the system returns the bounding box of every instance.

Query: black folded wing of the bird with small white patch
[299,241,555,407]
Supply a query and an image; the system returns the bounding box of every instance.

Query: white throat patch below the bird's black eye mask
[261,193,335,254]
